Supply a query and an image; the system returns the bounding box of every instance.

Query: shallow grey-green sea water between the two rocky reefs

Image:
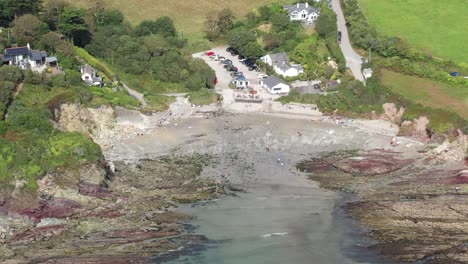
[161,186,392,264]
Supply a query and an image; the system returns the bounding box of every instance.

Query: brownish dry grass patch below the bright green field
[381,70,468,120]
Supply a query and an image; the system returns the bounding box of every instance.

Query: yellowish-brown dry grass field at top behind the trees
[67,0,287,46]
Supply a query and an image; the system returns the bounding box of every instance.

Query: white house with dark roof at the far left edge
[2,43,47,69]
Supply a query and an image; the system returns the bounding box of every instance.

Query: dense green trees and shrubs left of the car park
[86,14,215,90]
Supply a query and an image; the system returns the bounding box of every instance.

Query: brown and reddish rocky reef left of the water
[0,155,224,264]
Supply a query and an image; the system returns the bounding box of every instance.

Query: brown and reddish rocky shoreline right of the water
[298,137,468,264]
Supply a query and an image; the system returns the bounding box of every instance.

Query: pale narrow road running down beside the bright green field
[332,0,364,82]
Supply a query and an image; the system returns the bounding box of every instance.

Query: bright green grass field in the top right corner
[358,0,468,63]
